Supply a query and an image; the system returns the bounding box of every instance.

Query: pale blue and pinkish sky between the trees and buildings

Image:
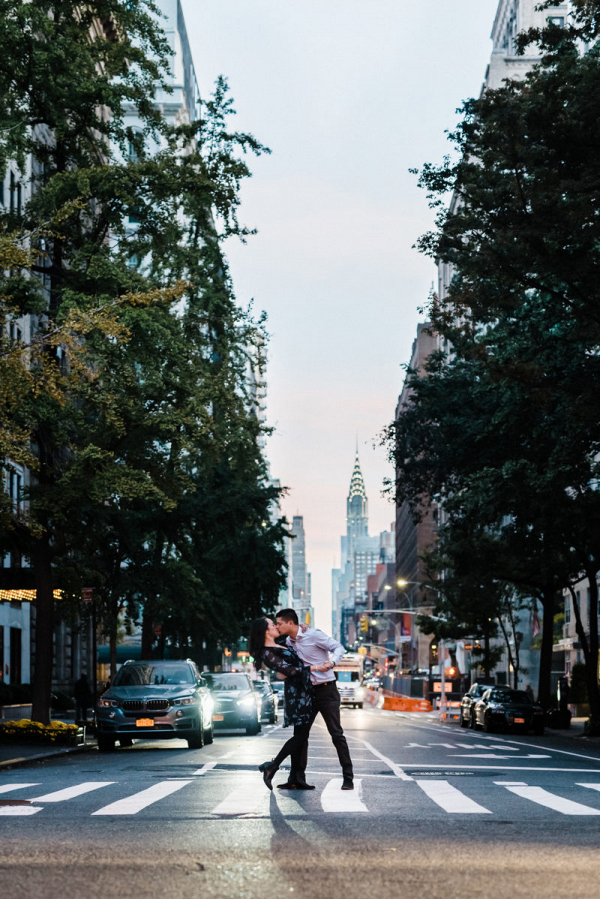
[182,0,498,631]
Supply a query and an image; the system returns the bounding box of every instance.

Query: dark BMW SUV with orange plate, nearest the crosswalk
[96,659,213,752]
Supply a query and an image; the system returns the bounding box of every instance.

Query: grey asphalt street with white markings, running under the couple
[0,709,600,899]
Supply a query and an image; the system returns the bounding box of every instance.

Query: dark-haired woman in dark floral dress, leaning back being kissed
[250,618,322,790]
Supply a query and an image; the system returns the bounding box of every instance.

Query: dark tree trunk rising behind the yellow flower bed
[31,529,54,724]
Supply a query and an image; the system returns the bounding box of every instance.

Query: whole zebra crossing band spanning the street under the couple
[0,765,600,823]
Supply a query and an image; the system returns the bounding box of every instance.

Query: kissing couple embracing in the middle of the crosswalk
[250,609,354,790]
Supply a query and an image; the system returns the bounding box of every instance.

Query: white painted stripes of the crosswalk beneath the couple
[0,769,600,818]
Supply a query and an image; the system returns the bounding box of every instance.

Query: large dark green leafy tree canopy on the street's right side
[390,2,600,718]
